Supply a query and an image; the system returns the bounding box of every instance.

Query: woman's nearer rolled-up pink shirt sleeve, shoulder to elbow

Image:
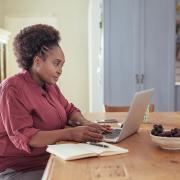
[0,87,39,153]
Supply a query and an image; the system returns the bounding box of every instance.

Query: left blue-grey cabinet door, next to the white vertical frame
[104,0,139,105]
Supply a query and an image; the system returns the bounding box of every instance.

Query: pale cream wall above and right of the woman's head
[0,0,89,111]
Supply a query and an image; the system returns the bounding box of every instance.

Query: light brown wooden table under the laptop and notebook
[43,112,180,180]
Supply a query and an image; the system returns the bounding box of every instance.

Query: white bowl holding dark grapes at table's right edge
[150,133,180,150]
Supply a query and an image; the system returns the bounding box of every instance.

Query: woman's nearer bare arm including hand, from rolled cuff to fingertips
[29,126,103,147]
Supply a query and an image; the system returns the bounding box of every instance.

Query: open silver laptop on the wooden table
[103,89,154,143]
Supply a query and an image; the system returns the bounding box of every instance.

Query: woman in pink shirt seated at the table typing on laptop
[0,24,110,180]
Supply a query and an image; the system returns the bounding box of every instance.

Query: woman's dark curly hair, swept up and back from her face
[13,24,60,70]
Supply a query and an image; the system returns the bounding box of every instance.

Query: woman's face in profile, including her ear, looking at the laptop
[35,46,65,84]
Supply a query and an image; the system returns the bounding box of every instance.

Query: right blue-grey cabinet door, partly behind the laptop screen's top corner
[141,0,175,111]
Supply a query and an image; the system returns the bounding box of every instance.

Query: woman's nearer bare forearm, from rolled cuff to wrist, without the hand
[29,128,71,147]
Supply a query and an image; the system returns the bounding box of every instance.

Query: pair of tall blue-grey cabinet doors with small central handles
[104,0,175,111]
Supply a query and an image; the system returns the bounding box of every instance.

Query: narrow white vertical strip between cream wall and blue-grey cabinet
[88,0,104,112]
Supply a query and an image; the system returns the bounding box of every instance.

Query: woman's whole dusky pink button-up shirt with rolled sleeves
[0,70,79,172]
